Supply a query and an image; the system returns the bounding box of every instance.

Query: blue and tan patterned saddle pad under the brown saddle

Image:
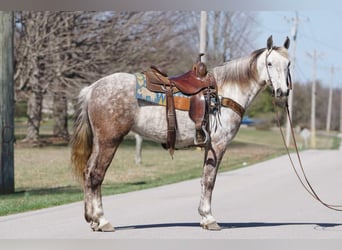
[135,73,190,110]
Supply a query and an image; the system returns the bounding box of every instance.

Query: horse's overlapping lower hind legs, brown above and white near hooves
[84,138,122,231]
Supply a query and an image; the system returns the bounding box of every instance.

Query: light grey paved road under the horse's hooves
[0,150,342,239]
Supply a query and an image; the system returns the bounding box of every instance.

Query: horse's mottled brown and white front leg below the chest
[198,146,223,230]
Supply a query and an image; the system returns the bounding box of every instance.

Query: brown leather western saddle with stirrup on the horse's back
[144,54,220,156]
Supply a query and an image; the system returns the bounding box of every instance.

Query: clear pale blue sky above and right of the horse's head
[255,10,342,88]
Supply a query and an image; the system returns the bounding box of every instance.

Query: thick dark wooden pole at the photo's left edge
[0,11,14,194]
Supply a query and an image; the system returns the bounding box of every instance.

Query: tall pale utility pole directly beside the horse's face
[285,12,299,147]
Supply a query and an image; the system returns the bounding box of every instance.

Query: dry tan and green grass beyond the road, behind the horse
[0,125,338,216]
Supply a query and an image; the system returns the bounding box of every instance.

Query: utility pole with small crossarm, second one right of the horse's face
[308,50,317,148]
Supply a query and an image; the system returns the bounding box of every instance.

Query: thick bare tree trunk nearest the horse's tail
[53,93,69,140]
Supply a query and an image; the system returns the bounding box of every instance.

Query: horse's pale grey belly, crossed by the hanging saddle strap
[132,106,195,146]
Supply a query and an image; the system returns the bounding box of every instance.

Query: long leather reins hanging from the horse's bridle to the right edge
[272,99,342,212]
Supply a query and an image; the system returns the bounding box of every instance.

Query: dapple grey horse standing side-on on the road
[71,36,290,231]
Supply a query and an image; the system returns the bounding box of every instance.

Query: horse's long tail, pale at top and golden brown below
[70,87,93,183]
